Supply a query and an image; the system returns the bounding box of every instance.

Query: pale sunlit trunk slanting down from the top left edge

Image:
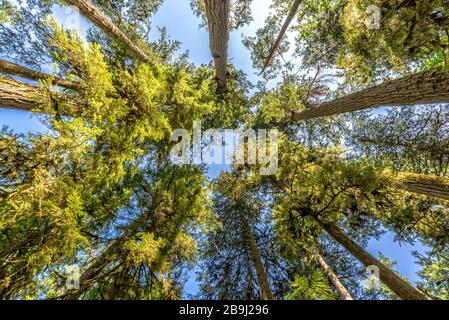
[64,0,152,63]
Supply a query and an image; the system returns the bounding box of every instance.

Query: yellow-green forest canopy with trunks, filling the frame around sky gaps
[0,0,449,300]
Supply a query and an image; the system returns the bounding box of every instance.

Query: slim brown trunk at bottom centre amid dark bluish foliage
[240,213,273,300]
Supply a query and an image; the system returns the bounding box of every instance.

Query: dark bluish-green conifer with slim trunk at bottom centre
[202,173,282,300]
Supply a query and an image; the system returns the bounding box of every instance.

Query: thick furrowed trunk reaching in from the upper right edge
[292,70,449,121]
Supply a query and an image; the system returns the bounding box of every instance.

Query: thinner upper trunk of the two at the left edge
[0,59,82,90]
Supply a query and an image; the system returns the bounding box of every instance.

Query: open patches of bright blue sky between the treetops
[0,0,426,294]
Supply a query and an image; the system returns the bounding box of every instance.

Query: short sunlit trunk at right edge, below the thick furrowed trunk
[397,172,449,200]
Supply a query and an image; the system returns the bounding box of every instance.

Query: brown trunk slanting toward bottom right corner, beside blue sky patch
[312,215,426,300]
